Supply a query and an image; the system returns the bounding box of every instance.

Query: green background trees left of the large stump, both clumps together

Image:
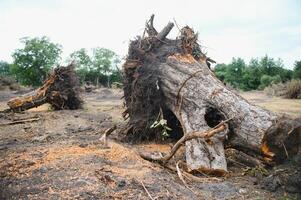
[0,37,121,86]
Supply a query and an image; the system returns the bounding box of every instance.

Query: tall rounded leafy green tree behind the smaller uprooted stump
[11,37,62,86]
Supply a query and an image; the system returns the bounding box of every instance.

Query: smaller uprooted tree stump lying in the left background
[7,64,83,111]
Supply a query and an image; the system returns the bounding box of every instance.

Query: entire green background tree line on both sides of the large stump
[0,37,301,91]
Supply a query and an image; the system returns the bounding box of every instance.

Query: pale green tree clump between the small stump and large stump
[70,48,121,87]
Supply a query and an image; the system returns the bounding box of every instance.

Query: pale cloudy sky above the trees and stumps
[0,0,301,69]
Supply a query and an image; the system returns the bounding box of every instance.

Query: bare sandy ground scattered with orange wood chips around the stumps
[0,89,301,199]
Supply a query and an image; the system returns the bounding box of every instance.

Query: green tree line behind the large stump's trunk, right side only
[214,55,301,91]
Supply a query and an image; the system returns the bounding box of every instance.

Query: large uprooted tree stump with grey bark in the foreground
[123,16,301,175]
